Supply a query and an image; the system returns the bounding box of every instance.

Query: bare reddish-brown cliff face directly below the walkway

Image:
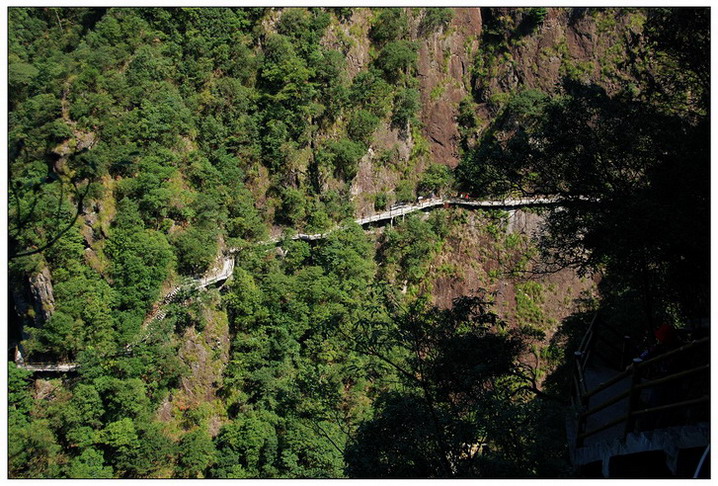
[426,210,595,326]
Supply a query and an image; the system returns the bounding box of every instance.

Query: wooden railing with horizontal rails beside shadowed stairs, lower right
[576,336,710,447]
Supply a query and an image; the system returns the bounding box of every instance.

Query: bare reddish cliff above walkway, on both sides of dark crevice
[417,8,645,173]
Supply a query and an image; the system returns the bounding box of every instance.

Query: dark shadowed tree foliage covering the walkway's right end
[464,23,708,325]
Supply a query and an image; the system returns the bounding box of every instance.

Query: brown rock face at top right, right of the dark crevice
[474,8,645,101]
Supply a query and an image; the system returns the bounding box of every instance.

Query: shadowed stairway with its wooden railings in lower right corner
[567,321,710,478]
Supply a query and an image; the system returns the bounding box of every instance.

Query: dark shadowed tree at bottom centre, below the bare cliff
[345,298,540,478]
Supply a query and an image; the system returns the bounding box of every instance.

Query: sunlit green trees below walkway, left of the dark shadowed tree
[217,225,382,478]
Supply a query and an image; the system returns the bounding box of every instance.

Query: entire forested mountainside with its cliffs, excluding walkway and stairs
[7,7,710,478]
